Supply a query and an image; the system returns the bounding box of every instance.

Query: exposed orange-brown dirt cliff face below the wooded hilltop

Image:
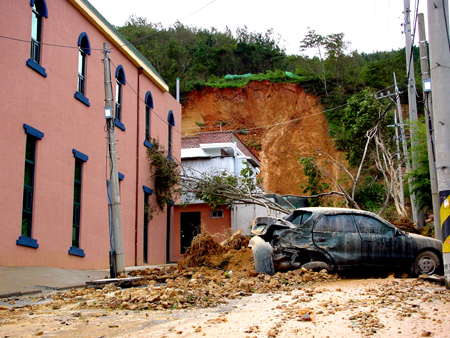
[182,81,344,195]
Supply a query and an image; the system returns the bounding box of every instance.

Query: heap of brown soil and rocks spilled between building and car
[0,231,338,311]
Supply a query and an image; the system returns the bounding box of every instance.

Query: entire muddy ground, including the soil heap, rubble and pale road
[0,236,450,338]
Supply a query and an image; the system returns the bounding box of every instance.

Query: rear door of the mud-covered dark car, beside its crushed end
[313,214,362,269]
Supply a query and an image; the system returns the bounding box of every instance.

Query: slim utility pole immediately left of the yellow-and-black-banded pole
[418,13,442,241]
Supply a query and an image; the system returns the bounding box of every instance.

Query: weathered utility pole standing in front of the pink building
[103,42,125,277]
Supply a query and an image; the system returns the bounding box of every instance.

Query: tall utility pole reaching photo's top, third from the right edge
[403,0,423,228]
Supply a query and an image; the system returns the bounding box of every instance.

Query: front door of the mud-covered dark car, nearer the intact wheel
[354,214,398,266]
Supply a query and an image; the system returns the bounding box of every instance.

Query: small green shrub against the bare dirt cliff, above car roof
[297,156,329,207]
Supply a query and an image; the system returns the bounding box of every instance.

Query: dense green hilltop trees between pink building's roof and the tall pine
[117,20,287,94]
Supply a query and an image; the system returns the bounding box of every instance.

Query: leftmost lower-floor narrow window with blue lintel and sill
[16,124,44,248]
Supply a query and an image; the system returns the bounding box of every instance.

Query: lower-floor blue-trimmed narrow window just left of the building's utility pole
[69,149,89,257]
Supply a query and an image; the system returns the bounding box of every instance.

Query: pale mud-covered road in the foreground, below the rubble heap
[0,276,450,338]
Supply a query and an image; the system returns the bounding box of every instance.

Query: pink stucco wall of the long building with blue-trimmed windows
[0,0,181,269]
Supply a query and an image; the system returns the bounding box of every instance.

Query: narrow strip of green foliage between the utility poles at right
[406,121,433,210]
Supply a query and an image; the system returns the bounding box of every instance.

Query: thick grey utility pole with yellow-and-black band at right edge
[428,0,450,289]
